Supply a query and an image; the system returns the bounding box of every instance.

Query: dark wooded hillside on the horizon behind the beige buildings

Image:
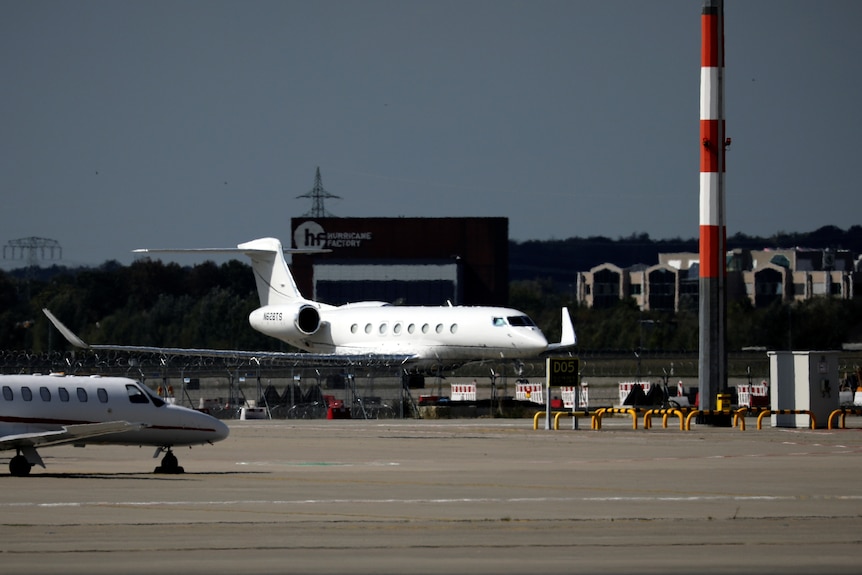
[509,226,862,284]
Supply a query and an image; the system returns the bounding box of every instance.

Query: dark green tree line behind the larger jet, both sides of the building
[0,226,862,353]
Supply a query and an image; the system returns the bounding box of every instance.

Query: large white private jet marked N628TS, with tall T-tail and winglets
[43,238,577,369]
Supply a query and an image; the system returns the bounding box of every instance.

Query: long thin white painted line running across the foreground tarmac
[5,495,862,508]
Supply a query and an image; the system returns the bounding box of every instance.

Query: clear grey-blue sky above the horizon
[0,0,862,267]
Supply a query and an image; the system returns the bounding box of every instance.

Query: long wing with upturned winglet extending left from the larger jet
[42,308,416,366]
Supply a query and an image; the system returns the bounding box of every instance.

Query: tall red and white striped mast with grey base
[698,0,730,410]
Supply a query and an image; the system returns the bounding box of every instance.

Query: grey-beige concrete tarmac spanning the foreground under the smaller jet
[0,416,862,575]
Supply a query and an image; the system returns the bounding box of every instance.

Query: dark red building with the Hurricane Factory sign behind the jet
[291,218,509,306]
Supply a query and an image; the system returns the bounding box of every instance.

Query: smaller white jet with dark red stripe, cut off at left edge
[0,374,229,477]
